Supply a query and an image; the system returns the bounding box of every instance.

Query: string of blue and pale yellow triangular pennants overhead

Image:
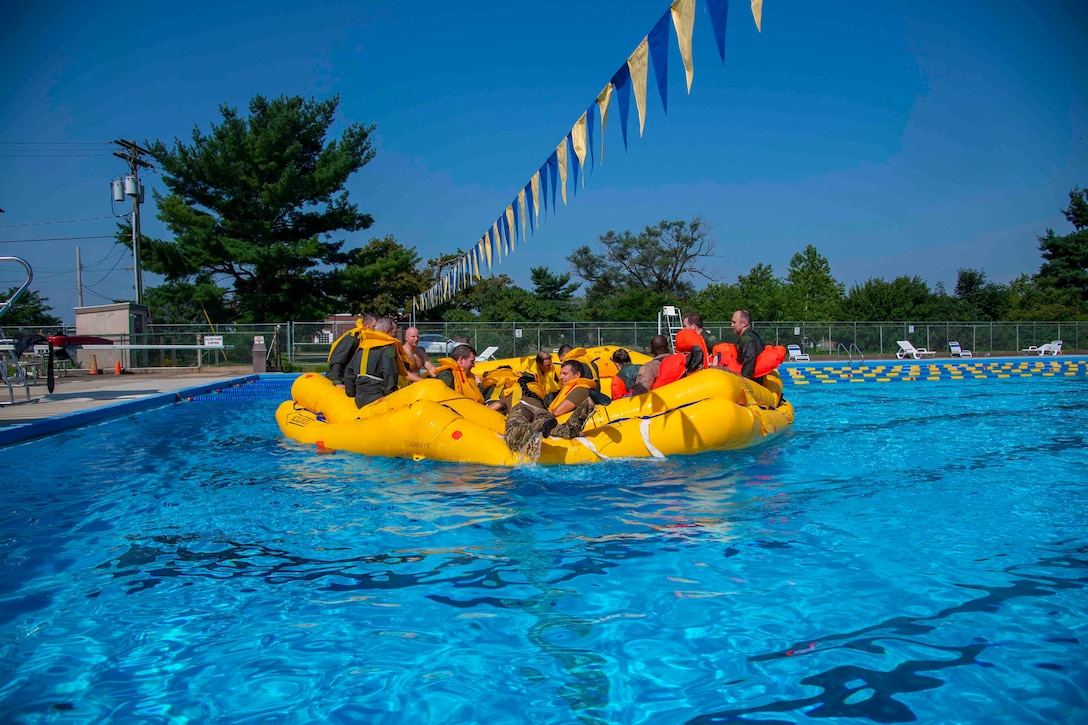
[415,0,763,311]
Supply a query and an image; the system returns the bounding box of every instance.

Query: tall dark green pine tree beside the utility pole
[141,96,374,322]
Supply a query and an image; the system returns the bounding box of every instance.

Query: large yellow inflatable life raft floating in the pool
[276,348,793,466]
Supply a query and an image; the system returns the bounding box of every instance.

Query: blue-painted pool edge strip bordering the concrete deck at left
[0,373,274,447]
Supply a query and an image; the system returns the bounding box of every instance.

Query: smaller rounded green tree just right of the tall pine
[336,236,429,317]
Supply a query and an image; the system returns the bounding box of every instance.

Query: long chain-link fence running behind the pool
[3,319,1088,370]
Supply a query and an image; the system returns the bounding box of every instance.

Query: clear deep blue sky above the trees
[0,0,1088,321]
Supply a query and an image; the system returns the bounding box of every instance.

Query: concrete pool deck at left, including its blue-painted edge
[0,368,269,446]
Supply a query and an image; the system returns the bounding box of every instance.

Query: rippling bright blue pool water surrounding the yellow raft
[0,378,1088,725]
